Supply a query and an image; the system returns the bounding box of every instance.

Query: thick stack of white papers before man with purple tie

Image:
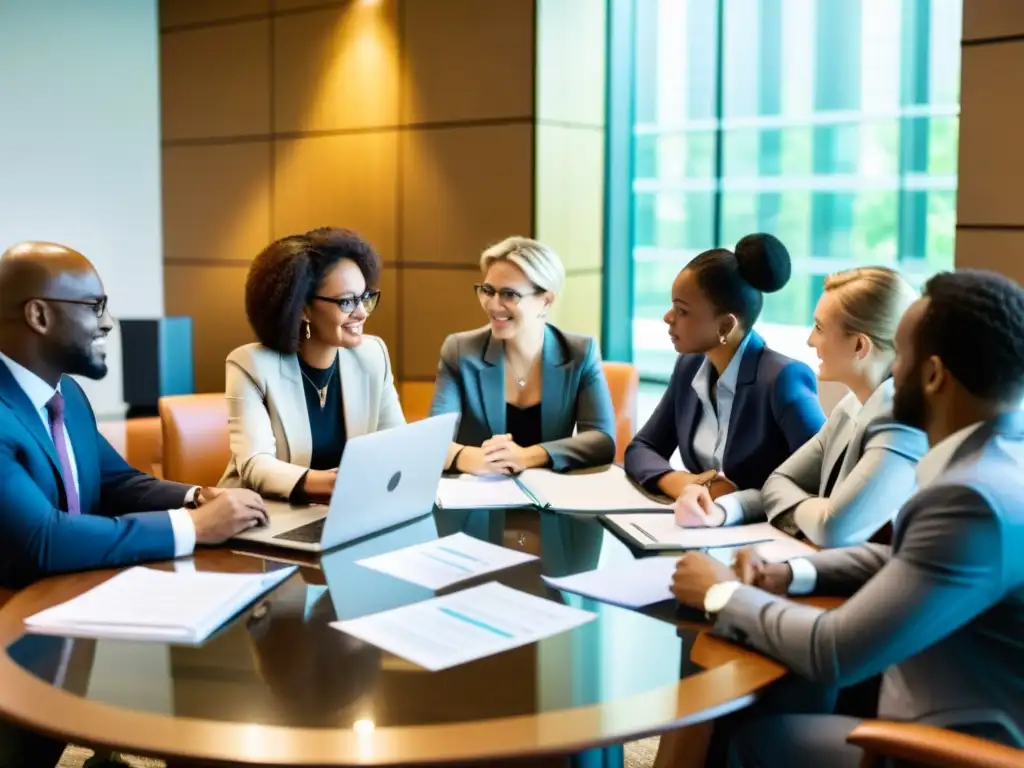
[25,566,297,644]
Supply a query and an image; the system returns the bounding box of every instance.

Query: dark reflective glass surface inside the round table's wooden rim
[8,510,698,728]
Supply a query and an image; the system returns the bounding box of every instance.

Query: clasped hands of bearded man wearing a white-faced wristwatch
[671,548,793,610]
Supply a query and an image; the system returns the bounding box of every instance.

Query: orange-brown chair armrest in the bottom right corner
[846,720,1024,768]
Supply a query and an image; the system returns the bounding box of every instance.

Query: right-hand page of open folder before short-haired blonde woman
[519,465,672,513]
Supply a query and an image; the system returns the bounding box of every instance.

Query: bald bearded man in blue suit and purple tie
[0,243,266,768]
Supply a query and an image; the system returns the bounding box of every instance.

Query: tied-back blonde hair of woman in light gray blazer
[825,266,918,352]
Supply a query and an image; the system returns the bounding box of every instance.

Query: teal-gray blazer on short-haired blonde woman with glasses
[430,326,615,471]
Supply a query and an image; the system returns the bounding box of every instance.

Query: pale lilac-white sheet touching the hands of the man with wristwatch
[543,556,679,608]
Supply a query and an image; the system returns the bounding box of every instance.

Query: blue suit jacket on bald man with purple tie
[0,361,191,589]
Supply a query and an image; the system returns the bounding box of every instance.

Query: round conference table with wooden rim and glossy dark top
[0,509,785,766]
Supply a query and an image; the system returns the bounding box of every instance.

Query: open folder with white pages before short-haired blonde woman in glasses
[437,466,672,513]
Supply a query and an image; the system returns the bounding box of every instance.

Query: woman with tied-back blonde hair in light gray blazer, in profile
[679,266,928,547]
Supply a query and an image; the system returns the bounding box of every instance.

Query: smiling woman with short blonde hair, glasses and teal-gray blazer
[430,237,615,474]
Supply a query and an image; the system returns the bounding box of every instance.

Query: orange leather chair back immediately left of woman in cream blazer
[159,393,231,485]
